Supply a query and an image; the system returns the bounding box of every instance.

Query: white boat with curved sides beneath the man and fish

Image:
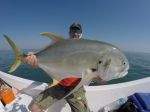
[0,71,150,112]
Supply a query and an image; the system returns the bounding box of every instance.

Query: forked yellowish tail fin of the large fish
[4,35,23,73]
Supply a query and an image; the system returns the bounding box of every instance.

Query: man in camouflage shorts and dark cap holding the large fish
[24,23,90,112]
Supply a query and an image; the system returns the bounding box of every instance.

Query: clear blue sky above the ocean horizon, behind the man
[0,0,150,53]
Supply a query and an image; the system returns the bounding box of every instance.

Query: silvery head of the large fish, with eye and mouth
[97,48,129,81]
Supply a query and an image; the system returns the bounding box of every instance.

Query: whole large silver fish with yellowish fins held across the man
[4,32,129,96]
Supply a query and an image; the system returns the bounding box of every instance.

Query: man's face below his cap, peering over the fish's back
[70,29,82,39]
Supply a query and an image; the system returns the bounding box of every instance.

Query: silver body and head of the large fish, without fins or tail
[36,39,129,80]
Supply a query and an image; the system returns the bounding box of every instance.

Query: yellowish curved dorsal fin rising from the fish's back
[40,32,64,42]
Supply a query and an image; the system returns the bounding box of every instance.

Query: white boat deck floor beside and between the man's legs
[0,88,71,112]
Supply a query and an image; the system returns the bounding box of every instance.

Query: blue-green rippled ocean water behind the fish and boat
[0,50,150,84]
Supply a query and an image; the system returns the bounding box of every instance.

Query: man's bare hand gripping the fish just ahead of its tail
[23,52,38,67]
